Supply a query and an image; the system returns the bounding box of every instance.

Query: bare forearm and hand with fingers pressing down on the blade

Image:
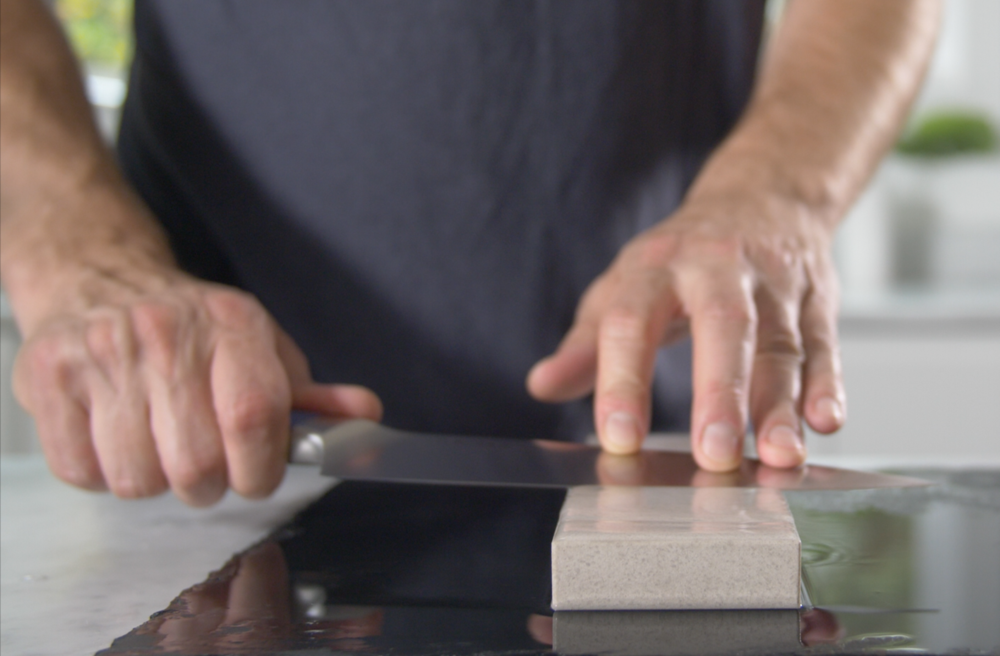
[528,0,939,471]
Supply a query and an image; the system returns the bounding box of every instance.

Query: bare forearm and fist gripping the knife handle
[0,0,382,505]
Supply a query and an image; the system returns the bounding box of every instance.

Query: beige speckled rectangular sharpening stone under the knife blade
[552,486,801,611]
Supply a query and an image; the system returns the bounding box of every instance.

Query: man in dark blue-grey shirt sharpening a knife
[0,0,938,504]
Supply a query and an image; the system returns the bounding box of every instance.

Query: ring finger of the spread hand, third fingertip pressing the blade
[750,287,806,468]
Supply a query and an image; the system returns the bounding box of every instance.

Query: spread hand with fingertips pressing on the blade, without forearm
[529,195,844,471]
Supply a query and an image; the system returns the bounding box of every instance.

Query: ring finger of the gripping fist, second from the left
[84,314,167,499]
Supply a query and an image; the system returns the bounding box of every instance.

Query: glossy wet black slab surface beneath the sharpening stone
[100,471,1000,656]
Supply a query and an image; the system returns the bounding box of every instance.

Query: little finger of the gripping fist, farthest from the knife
[12,340,108,492]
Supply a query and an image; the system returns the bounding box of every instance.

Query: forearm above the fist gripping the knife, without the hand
[0,0,172,330]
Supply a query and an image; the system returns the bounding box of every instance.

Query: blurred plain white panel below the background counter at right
[808,319,1000,466]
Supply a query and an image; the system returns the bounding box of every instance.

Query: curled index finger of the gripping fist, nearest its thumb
[211,325,291,498]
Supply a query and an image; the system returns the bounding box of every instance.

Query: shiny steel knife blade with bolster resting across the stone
[289,419,928,490]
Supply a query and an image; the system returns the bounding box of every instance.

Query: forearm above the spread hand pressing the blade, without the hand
[690,0,940,229]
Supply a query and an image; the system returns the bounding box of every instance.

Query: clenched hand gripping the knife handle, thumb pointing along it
[13,268,381,505]
